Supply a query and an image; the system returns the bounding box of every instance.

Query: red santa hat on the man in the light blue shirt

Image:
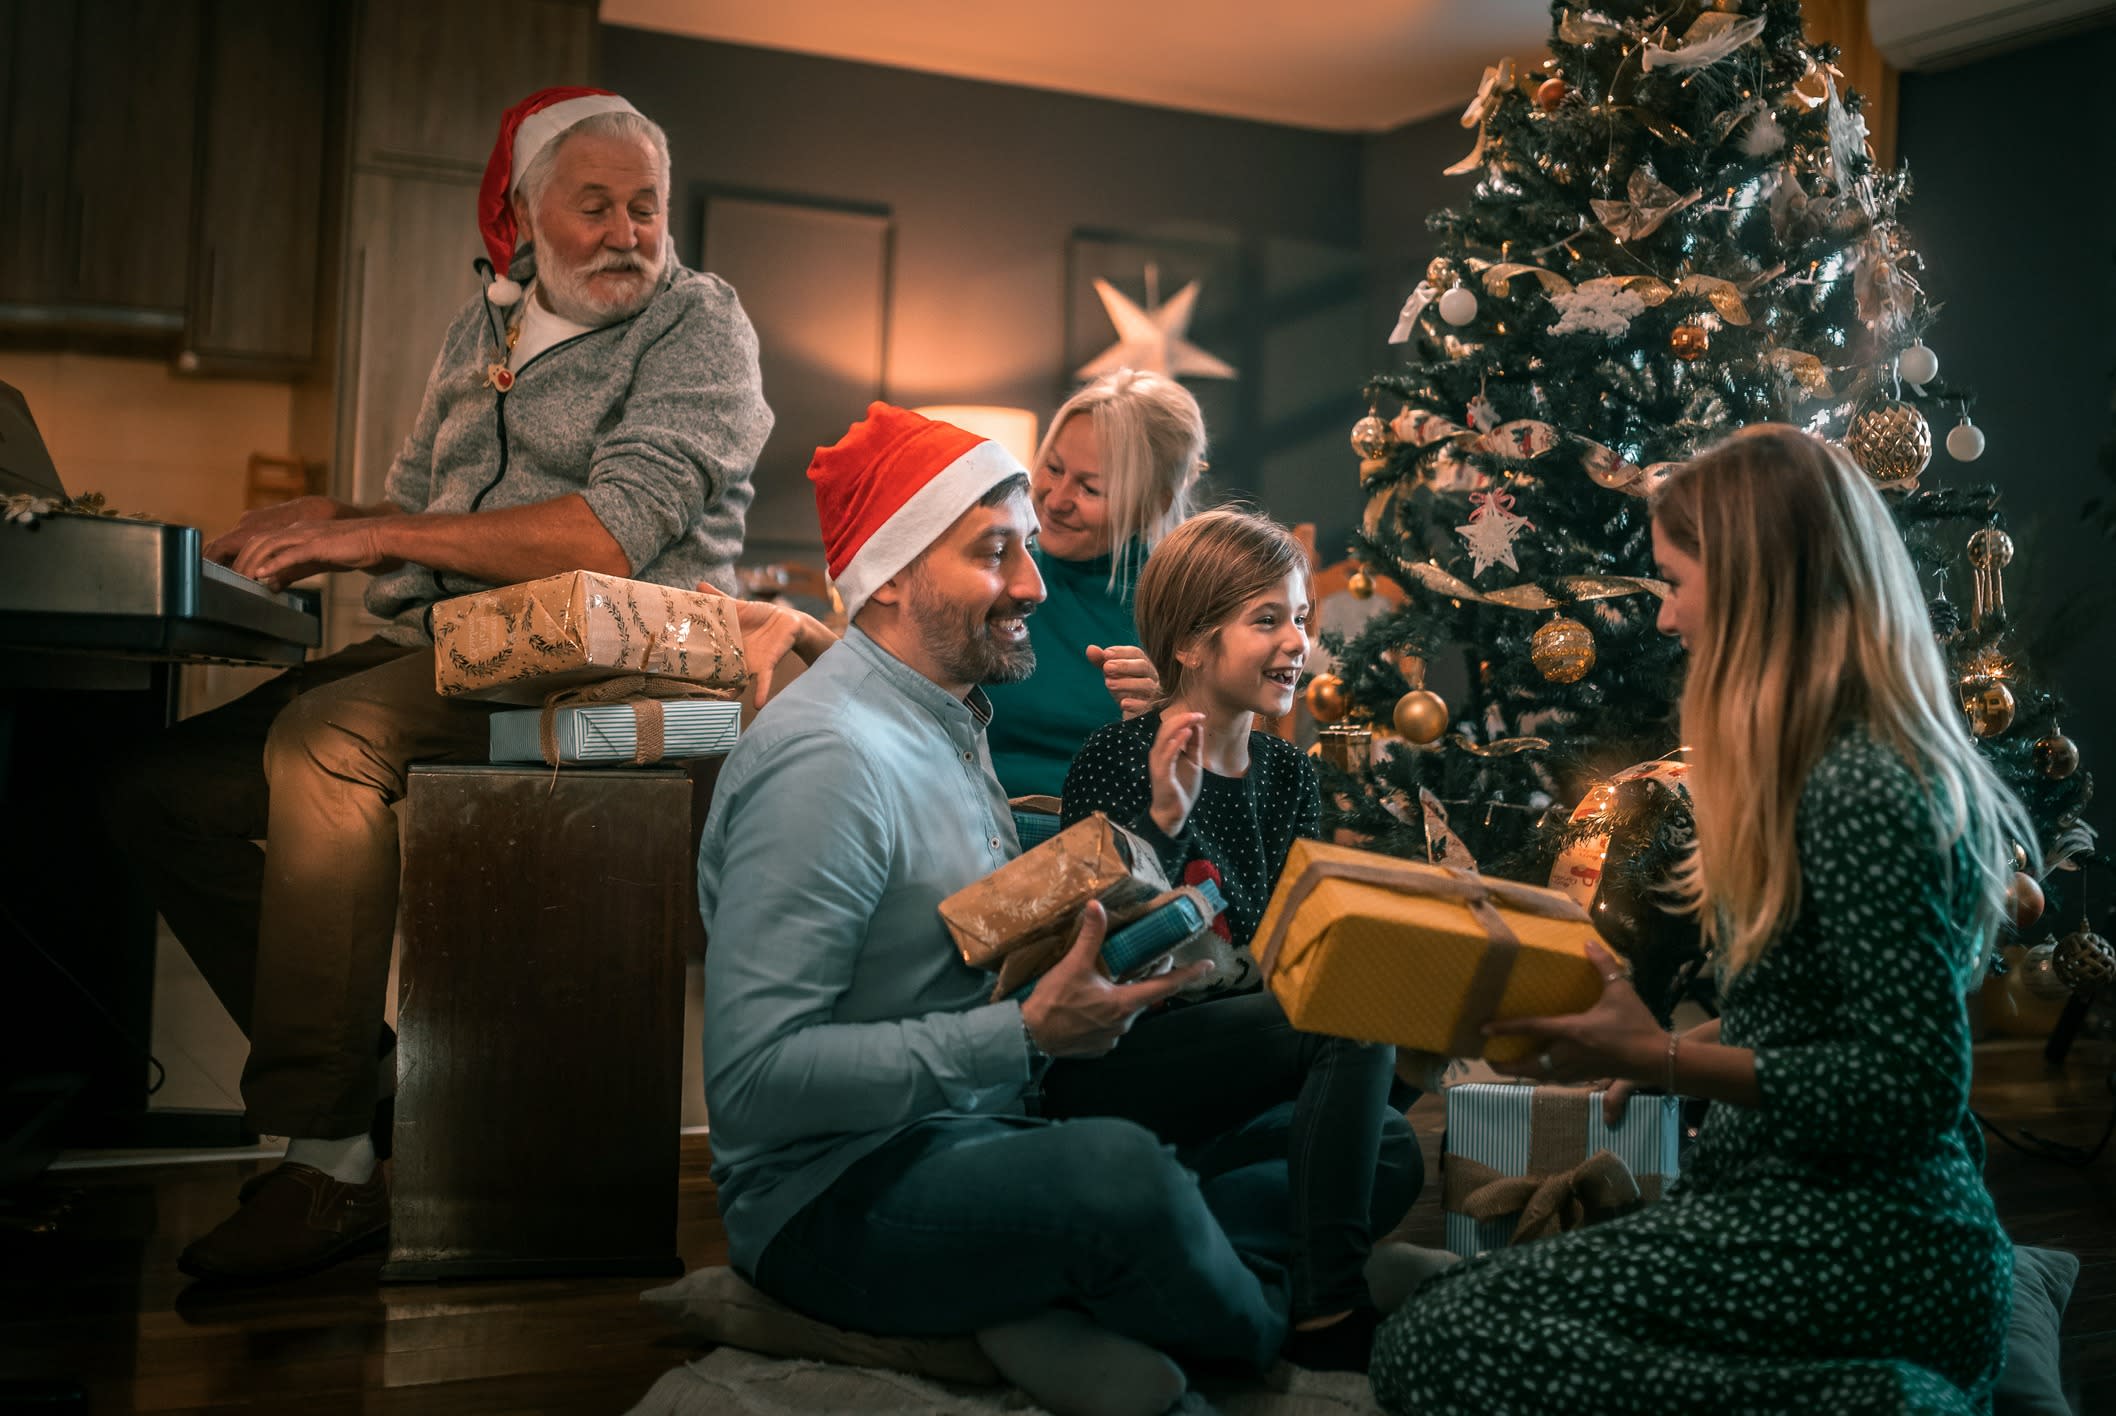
[808,402,1026,620]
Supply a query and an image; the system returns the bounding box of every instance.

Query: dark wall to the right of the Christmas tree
[1898,28,2116,838]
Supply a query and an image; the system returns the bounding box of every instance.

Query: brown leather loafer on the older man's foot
[176,1162,389,1283]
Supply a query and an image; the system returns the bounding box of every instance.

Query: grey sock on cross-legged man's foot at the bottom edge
[978,1308,1189,1416]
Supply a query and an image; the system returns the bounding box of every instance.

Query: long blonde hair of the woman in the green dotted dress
[1653,423,2036,972]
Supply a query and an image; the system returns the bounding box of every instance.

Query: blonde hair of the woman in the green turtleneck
[1033,368,1204,586]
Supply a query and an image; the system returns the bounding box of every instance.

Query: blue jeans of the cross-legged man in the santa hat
[753,1115,1289,1372]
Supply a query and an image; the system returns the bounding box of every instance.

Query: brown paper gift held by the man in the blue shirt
[940,813,1168,997]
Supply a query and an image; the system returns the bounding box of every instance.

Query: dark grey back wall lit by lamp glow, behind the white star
[601,25,1369,558]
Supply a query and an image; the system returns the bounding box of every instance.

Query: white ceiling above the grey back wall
[601,0,1551,131]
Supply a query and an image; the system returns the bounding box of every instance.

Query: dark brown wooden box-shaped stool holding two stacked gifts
[381,764,698,1281]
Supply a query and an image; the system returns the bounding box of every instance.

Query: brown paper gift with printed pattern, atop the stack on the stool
[434,569,749,703]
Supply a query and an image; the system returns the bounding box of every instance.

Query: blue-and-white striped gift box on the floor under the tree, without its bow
[1441,1082,1682,1259]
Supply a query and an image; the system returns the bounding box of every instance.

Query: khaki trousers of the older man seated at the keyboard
[104,639,495,1137]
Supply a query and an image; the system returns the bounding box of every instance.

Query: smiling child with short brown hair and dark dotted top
[1043,510,1422,1367]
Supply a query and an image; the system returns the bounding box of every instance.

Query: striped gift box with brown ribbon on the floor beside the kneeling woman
[1441,1082,1682,1259]
